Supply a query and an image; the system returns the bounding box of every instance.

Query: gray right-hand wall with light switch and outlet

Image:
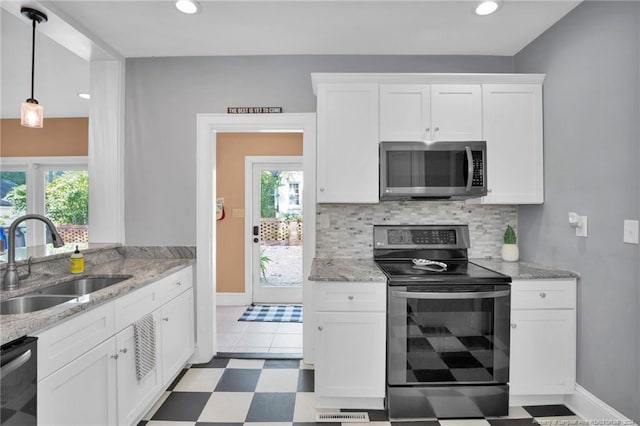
[514,1,640,422]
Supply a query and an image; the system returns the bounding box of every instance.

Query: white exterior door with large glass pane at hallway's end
[245,156,304,303]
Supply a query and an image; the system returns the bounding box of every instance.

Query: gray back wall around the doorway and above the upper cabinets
[125,56,513,245]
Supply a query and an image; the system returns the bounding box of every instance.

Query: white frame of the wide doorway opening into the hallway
[192,113,316,363]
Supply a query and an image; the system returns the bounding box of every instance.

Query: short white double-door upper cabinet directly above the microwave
[380,84,482,141]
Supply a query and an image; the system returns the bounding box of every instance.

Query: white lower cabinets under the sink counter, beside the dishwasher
[38,266,194,426]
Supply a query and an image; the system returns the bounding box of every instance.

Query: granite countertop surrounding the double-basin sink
[0,257,195,344]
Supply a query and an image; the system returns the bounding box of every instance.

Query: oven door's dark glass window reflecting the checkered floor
[405,292,509,384]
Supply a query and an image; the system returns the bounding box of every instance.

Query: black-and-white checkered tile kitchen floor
[139,358,580,426]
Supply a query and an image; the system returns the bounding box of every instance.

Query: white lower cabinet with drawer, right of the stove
[509,279,576,395]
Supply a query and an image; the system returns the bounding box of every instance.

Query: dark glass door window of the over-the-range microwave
[387,151,468,188]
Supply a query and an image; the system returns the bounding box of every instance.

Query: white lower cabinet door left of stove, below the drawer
[315,312,386,398]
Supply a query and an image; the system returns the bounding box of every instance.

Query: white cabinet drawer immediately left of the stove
[313,281,387,312]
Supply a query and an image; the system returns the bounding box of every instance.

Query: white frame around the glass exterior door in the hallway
[244,155,304,303]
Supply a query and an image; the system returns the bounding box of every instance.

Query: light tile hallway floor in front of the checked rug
[216,306,302,354]
